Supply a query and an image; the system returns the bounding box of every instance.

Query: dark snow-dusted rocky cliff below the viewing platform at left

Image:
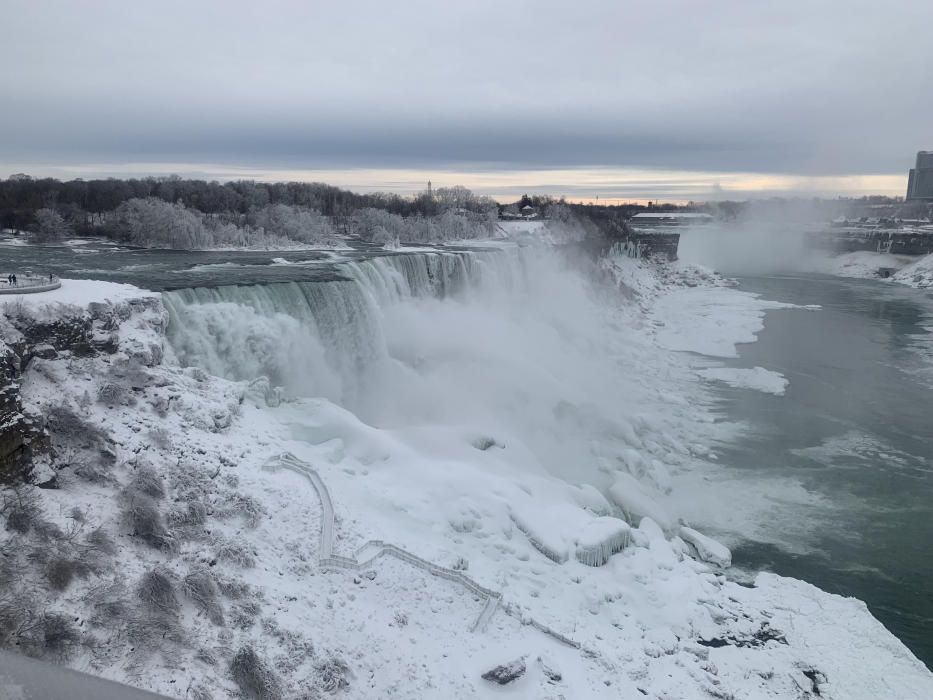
[0,297,167,484]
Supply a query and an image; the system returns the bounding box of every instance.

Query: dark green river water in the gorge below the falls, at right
[717,275,933,667]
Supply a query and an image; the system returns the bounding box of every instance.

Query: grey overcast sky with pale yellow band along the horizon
[0,0,933,199]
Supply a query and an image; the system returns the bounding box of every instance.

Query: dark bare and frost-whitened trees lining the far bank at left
[0,175,510,249]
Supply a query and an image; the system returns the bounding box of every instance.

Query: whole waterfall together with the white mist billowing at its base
[164,247,712,488]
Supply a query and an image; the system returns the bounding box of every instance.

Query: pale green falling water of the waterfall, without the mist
[164,250,522,406]
